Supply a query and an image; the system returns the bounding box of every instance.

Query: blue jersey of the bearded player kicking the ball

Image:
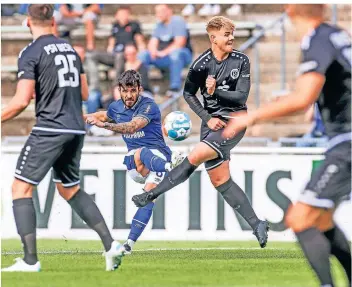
[107,96,171,161]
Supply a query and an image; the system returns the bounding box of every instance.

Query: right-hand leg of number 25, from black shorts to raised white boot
[53,135,124,271]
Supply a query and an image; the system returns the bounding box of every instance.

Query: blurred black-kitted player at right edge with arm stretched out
[224,4,351,287]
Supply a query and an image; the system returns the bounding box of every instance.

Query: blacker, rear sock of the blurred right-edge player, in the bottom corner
[324,225,351,286]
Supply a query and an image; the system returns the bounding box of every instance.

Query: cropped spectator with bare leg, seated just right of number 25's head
[55,4,102,51]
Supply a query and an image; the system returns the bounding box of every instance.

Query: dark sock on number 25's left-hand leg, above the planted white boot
[13,198,38,265]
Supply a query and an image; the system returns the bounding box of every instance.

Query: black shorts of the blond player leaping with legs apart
[200,122,246,170]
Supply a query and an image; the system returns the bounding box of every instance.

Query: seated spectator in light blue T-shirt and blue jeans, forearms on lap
[139,4,192,97]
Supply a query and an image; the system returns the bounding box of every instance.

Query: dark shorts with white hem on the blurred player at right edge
[298,141,351,208]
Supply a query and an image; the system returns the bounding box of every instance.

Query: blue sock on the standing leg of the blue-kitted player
[128,202,154,242]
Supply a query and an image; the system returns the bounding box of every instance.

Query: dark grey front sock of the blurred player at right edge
[296,228,333,286]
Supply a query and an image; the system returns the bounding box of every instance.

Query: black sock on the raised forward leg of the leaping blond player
[152,157,197,198]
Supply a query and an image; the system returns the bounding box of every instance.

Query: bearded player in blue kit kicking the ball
[85,70,183,254]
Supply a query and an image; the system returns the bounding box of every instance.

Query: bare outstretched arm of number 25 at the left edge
[1,79,35,123]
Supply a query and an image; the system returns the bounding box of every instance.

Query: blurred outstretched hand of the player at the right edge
[222,112,255,139]
